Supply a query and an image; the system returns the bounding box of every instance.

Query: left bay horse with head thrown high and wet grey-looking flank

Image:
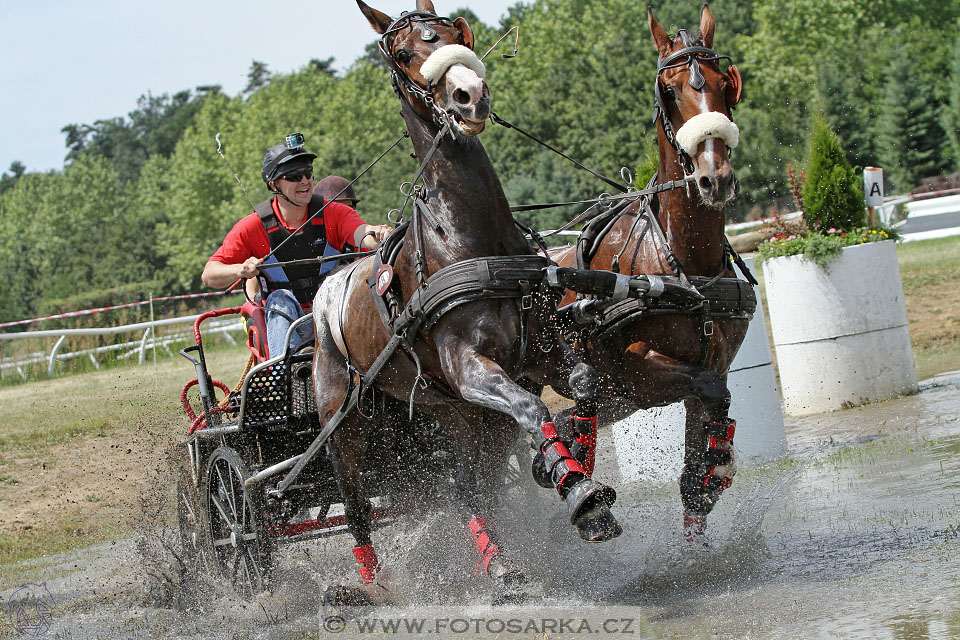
[313,0,620,601]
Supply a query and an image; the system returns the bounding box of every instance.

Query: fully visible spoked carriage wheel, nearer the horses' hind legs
[206,447,273,600]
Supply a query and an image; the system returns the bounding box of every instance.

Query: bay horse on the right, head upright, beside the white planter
[551,4,756,541]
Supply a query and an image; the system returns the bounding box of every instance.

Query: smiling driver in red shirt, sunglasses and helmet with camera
[200,133,391,357]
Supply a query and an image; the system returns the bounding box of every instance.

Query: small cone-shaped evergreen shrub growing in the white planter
[803,114,866,230]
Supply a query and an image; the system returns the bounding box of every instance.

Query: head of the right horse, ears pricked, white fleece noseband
[647,5,742,208]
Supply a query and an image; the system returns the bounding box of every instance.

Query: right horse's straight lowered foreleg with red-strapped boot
[680,370,737,542]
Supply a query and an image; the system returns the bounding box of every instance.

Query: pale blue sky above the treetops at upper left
[0,0,517,173]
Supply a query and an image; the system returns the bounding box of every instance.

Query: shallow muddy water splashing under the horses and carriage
[0,375,960,640]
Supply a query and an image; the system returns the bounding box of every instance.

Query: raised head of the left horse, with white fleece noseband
[357,0,490,136]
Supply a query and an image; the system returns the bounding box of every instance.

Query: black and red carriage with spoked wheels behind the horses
[177,302,464,598]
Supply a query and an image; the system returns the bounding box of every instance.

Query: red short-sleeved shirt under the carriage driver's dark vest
[210,198,365,264]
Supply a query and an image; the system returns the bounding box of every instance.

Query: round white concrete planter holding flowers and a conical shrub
[763,241,917,416]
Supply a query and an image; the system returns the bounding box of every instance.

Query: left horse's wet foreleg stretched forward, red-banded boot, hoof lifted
[437,334,620,542]
